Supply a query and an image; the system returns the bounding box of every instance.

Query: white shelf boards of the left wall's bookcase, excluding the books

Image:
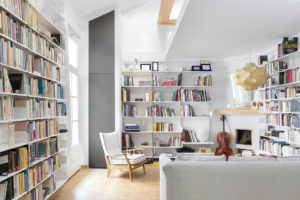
[0,0,69,200]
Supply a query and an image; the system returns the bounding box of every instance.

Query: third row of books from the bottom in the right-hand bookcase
[267,114,300,128]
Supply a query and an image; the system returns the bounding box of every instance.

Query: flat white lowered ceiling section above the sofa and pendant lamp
[167,0,300,59]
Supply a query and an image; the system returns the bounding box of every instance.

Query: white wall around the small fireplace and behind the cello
[211,55,264,151]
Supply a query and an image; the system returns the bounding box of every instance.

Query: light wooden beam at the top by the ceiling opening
[157,0,176,25]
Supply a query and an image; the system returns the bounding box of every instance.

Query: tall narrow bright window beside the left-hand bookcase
[68,38,79,145]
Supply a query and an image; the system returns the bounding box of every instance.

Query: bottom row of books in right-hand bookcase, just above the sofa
[260,139,300,157]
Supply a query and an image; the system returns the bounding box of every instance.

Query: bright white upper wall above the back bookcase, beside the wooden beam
[122,0,174,61]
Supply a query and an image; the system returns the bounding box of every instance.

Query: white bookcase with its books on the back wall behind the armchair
[121,67,213,158]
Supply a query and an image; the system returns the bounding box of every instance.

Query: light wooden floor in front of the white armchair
[50,164,159,200]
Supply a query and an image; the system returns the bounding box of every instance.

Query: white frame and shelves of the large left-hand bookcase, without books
[0,0,70,200]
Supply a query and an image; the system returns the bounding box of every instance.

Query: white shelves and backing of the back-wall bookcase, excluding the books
[121,61,214,158]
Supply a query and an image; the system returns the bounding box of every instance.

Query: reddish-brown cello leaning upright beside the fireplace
[215,115,233,161]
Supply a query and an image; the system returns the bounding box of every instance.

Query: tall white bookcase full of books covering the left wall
[0,0,70,200]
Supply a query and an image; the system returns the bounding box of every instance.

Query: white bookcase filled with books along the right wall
[259,51,300,157]
